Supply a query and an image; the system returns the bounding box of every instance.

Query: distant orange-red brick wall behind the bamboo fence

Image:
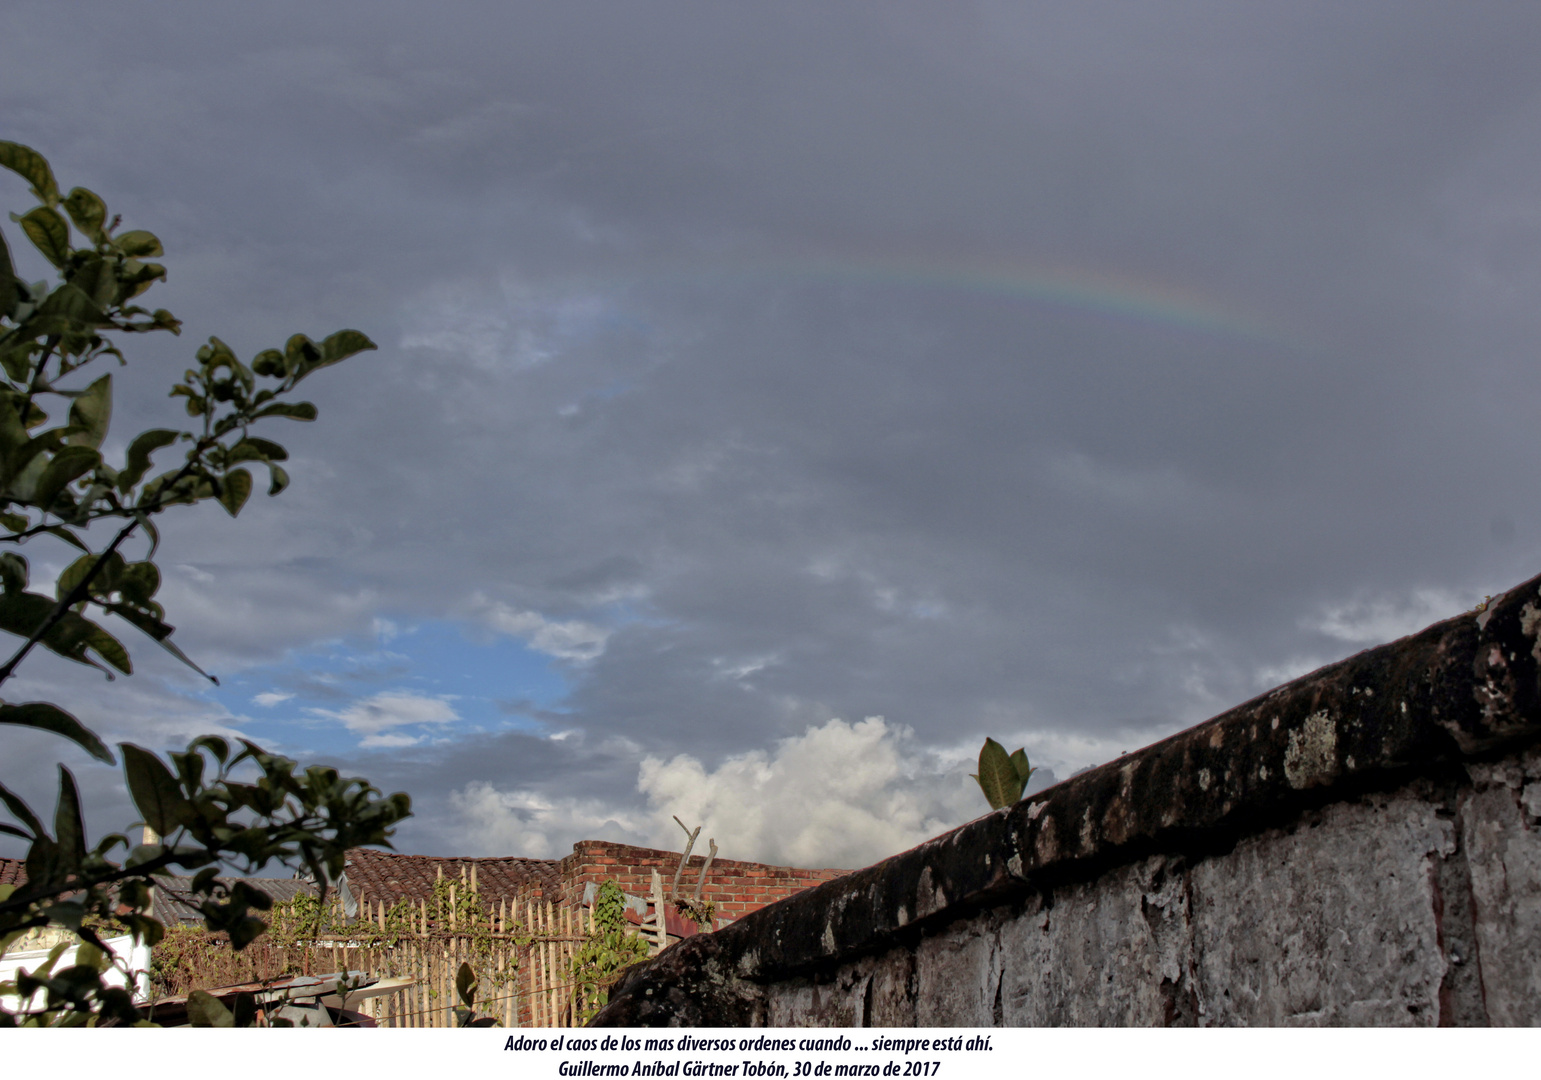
[558,840,851,920]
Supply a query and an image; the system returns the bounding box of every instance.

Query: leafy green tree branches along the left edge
[0,142,411,1026]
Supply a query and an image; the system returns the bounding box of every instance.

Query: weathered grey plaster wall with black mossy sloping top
[596,578,1541,1026]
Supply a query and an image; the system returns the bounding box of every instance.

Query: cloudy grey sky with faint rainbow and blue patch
[0,0,1541,867]
